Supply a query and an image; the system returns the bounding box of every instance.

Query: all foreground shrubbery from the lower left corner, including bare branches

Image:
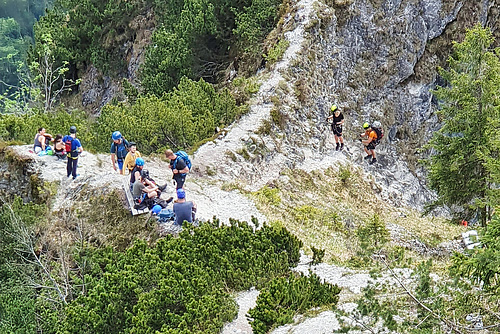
[0,200,348,334]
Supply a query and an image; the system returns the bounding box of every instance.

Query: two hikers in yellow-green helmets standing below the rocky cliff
[327,104,384,164]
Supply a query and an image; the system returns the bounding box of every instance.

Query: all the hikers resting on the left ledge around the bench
[33,126,196,226]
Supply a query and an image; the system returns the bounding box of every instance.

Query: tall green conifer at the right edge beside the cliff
[427,24,500,225]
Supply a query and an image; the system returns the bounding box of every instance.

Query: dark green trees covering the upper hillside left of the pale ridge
[31,0,281,97]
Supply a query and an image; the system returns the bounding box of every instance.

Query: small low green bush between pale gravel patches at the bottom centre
[248,274,340,334]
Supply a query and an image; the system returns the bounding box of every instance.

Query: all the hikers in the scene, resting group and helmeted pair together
[33,105,378,225]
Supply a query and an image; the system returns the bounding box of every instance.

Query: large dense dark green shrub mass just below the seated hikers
[55,220,302,333]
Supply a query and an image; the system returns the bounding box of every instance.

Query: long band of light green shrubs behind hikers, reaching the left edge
[0,78,241,154]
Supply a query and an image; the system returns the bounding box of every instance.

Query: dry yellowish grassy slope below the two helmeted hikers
[246,165,465,264]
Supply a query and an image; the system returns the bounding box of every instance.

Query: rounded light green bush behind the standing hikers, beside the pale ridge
[95,77,239,153]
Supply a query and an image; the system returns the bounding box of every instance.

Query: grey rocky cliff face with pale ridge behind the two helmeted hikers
[196,0,500,208]
